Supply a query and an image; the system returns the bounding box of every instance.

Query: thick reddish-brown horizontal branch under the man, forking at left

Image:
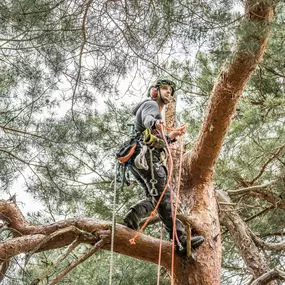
[0,200,174,269]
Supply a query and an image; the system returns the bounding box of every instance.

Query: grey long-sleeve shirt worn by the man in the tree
[133,99,162,133]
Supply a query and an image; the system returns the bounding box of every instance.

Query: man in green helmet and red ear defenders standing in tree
[124,79,204,254]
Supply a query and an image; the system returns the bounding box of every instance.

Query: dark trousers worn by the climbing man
[127,146,185,235]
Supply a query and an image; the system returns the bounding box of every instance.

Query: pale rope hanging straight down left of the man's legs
[109,162,118,285]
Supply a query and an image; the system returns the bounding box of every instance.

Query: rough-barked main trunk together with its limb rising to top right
[180,1,274,285]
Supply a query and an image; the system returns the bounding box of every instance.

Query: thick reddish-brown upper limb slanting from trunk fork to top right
[185,0,275,187]
